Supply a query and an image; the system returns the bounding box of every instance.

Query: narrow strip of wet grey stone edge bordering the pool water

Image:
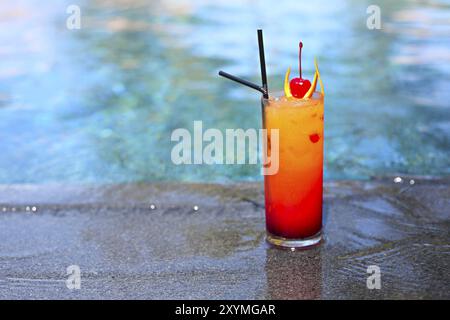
[0,175,450,206]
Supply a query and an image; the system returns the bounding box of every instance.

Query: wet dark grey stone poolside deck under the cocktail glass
[0,177,450,299]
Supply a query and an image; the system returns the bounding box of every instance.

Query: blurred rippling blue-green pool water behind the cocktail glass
[0,0,450,183]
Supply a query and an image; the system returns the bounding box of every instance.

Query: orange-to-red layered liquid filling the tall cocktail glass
[263,92,324,241]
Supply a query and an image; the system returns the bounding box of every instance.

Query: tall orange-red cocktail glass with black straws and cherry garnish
[219,30,325,249]
